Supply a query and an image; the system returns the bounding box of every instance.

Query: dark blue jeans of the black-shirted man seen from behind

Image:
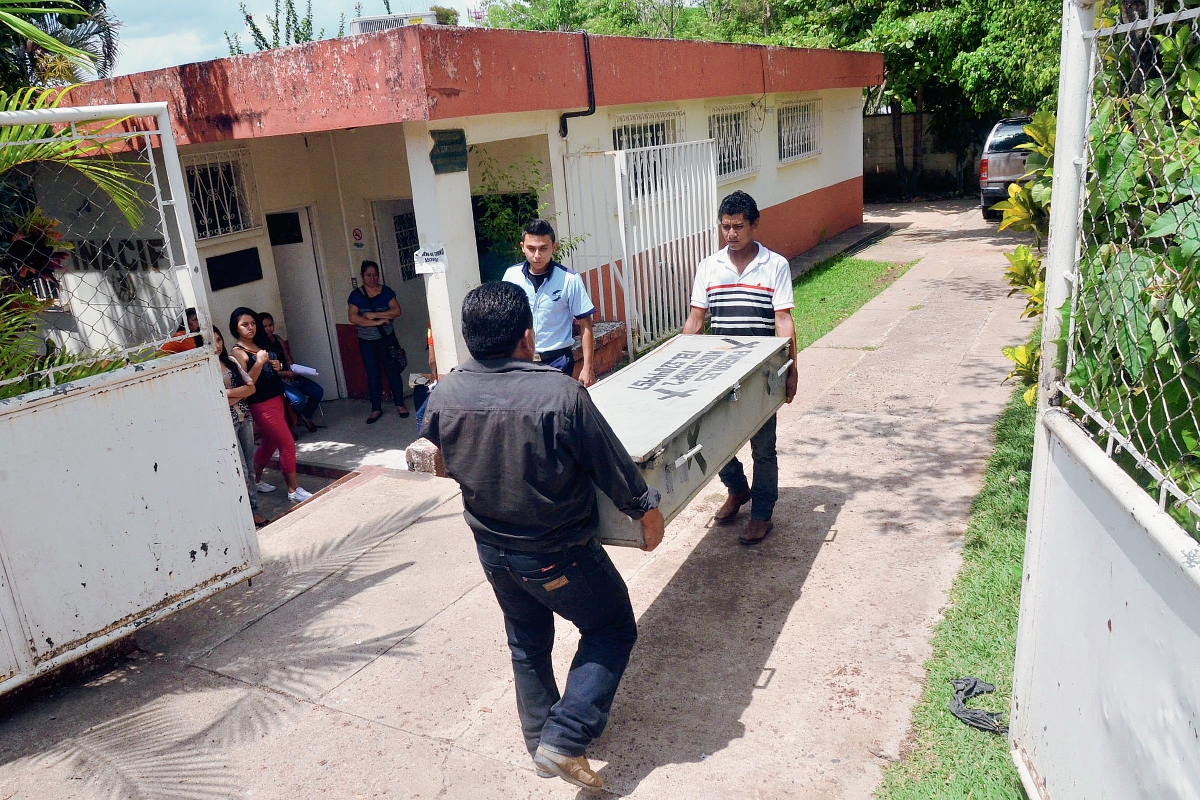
[478,540,637,756]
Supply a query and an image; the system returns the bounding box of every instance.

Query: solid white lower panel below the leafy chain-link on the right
[1012,410,1200,800]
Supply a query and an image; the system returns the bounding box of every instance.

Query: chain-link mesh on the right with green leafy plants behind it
[1056,0,1200,533]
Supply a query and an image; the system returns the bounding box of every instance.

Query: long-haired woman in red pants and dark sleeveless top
[229,308,312,503]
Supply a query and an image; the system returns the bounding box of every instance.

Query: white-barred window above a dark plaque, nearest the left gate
[181,150,260,240]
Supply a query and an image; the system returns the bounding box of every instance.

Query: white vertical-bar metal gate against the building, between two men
[566,139,718,357]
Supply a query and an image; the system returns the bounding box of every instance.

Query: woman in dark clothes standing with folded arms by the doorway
[347,261,408,425]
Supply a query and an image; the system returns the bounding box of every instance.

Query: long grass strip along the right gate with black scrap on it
[876,390,1033,800]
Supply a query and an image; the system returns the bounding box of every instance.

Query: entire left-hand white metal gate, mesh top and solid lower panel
[0,103,262,694]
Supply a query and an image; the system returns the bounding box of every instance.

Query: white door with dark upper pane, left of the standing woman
[266,209,338,398]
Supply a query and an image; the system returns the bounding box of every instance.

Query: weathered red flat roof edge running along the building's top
[68,25,883,144]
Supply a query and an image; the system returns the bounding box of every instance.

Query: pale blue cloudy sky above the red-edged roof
[108,0,478,74]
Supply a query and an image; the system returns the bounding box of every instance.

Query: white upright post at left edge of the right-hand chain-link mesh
[1038,0,1096,414]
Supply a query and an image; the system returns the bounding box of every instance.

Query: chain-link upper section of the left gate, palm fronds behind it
[0,92,200,398]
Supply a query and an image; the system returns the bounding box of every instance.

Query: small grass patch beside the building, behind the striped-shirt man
[792,255,912,350]
